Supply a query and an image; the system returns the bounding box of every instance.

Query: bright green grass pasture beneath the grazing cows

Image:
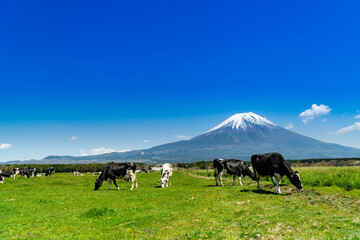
[0,167,360,239]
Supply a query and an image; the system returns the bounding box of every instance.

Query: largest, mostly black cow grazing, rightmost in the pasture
[251,153,303,194]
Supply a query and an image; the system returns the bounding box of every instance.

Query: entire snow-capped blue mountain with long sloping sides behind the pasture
[4,112,360,163]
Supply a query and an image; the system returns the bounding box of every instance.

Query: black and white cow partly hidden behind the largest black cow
[213,158,256,186]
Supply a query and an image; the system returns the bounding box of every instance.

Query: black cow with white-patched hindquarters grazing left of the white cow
[94,163,138,190]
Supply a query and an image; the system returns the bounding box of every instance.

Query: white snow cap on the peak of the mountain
[206,112,276,133]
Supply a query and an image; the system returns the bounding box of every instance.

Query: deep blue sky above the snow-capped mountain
[0,0,360,161]
